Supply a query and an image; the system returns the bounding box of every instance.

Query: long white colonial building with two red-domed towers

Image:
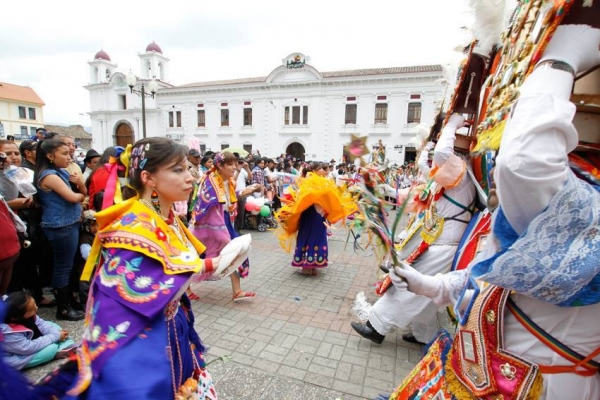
[86,42,445,162]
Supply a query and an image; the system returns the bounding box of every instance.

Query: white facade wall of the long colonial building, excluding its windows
[88,60,444,161]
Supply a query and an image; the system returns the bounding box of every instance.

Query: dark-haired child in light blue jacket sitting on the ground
[0,292,77,369]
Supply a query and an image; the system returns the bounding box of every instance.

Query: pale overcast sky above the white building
[0,0,486,125]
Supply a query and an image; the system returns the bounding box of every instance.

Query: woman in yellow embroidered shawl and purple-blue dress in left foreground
[31,138,249,400]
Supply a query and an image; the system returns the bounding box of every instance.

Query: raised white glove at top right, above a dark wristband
[540,25,600,74]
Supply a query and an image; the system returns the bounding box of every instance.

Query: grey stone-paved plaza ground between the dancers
[28,222,428,400]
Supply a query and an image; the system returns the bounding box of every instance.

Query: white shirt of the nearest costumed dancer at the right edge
[434,70,600,400]
